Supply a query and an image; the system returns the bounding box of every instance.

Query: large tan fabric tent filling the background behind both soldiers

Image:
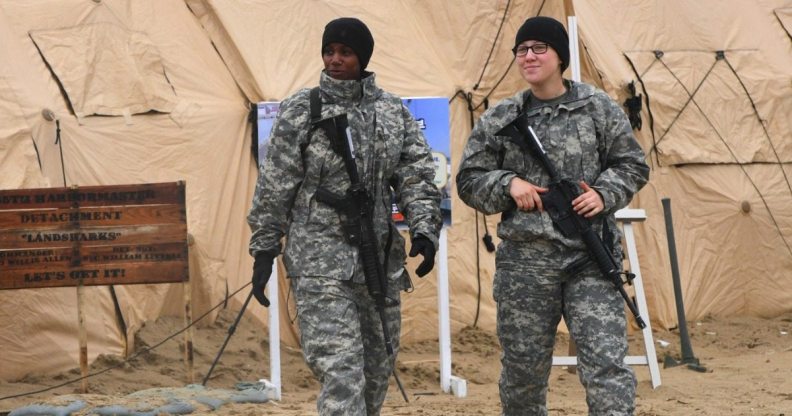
[0,0,792,380]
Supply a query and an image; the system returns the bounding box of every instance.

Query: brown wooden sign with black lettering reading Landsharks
[0,182,189,289]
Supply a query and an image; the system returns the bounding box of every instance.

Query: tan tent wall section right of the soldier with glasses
[575,0,792,326]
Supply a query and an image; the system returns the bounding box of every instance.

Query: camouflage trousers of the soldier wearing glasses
[494,254,636,416]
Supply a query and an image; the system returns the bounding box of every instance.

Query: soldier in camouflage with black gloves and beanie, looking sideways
[248,18,442,415]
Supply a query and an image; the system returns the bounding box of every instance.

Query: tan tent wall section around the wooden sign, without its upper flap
[0,0,258,379]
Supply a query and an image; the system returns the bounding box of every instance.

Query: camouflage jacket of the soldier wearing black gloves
[247,72,442,280]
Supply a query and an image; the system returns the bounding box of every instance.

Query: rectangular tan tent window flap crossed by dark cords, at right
[626,51,792,164]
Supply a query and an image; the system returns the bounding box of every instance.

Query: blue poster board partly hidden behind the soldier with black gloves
[257,97,451,226]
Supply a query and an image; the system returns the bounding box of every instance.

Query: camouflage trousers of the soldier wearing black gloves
[291,277,401,416]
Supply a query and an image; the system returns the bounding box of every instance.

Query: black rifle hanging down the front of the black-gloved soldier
[314,114,407,401]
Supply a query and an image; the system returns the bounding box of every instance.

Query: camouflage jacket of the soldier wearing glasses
[456,81,649,256]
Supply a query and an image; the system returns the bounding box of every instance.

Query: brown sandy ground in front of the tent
[0,311,792,416]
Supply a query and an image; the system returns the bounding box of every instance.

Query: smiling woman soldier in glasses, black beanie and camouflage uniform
[457,17,649,416]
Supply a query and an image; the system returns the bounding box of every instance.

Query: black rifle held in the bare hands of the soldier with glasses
[495,115,646,329]
